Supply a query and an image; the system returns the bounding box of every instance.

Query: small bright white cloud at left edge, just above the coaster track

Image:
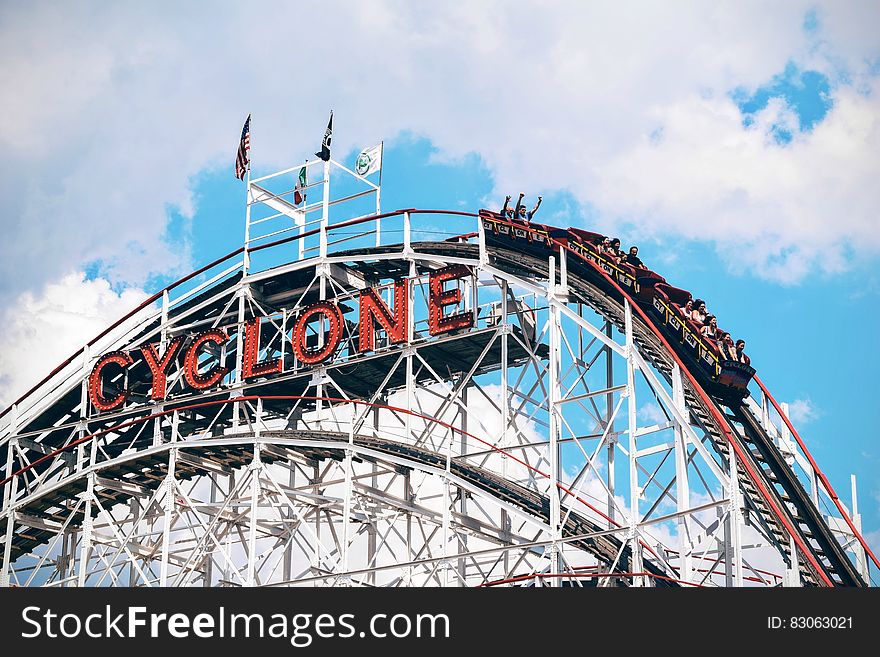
[0,272,146,408]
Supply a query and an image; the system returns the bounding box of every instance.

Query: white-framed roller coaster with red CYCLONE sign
[0,160,878,587]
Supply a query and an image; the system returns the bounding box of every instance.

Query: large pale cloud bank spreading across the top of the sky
[0,0,880,306]
